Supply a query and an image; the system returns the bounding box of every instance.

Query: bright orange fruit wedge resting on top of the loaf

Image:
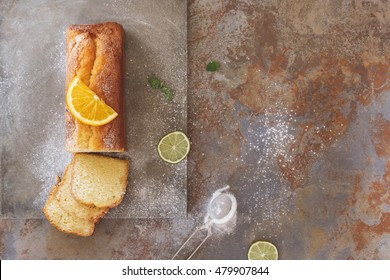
[66,76,118,126]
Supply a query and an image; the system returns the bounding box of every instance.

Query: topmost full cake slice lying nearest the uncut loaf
[71,153,129,208]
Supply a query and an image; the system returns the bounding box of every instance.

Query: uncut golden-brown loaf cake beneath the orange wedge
[66,22,126,153]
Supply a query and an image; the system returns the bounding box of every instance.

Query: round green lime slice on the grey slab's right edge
[157,131,190,163]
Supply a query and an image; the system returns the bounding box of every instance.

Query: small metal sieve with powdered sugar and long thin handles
[172,186,237,260]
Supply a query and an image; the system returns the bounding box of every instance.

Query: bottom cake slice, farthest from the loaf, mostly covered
[43,186,95,236]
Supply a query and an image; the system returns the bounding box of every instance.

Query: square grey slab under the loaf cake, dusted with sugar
[0,0,187,218]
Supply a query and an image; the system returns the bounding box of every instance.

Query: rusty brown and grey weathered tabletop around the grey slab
[2,0,390,259]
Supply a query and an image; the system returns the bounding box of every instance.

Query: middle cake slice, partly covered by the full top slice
[56,163,109,222]
